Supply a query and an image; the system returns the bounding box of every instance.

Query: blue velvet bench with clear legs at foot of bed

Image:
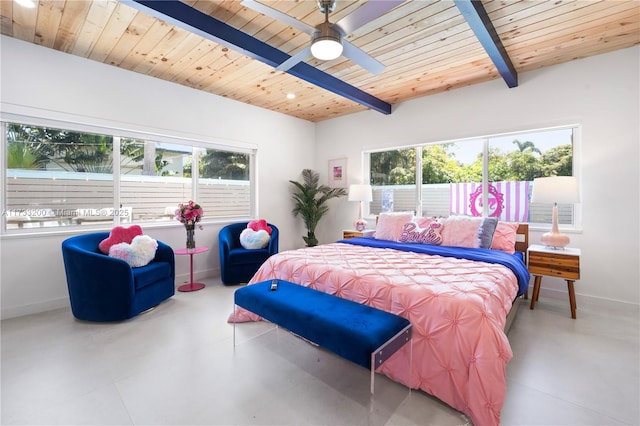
[234,280,412,394]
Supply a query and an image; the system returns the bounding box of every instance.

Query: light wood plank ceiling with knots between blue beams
[0,0,640,122]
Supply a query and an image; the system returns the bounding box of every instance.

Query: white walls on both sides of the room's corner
[0,36,640,318]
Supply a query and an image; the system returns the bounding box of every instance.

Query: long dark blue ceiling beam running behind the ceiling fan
[120,0,391,114]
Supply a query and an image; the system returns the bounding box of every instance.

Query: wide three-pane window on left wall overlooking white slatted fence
[2,123,255,233]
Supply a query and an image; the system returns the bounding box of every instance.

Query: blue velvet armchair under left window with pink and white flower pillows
[62,232,176,321]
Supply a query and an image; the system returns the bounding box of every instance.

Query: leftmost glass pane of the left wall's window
[3,123,114,229]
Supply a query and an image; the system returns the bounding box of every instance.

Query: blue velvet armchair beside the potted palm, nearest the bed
[218,222,278,285]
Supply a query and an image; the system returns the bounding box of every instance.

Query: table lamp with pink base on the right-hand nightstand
[531,176,580,249]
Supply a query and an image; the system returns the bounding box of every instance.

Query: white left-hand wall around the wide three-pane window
[0,36,315,318]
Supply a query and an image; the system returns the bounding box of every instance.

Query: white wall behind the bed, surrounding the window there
[316,47,640,309]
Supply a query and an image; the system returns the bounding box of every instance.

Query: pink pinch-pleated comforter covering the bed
[229,243,518,425]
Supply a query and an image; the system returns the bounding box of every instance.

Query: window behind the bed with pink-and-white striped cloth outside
[368,127,578,226]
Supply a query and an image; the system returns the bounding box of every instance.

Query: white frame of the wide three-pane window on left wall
[0,112,258,237]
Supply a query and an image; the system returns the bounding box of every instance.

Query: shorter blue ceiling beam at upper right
[454,0,518,87]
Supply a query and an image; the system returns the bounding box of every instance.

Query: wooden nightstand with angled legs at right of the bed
[527,244,580,319]
